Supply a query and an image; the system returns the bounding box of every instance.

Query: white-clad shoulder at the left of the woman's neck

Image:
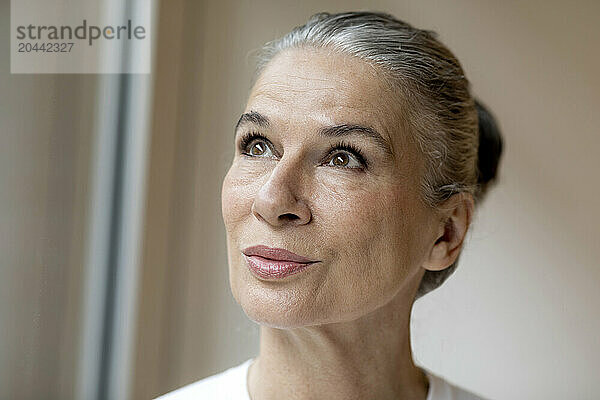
[154,358,253,400]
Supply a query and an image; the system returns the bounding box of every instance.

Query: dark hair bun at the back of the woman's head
[475,100,502,200]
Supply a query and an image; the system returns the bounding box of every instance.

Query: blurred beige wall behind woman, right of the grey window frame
[136,0,600,399]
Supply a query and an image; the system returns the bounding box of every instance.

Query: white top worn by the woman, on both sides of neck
[155,358,483,400]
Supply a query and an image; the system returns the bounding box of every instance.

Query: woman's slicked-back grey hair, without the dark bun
[256,12,499,298]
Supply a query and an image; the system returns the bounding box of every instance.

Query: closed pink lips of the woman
[242,245,318,279]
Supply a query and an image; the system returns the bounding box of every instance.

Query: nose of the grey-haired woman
[252,160,312,227]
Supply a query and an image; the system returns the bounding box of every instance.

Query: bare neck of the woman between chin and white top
[248,282,428,400]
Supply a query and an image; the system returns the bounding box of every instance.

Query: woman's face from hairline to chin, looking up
[222,49,435,328]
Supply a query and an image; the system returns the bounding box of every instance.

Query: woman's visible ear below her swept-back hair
[423,193,475,271]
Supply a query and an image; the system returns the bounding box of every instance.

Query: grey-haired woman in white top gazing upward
[156,12,501,400]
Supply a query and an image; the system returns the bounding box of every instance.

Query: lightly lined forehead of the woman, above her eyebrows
[246,48,406,145]
